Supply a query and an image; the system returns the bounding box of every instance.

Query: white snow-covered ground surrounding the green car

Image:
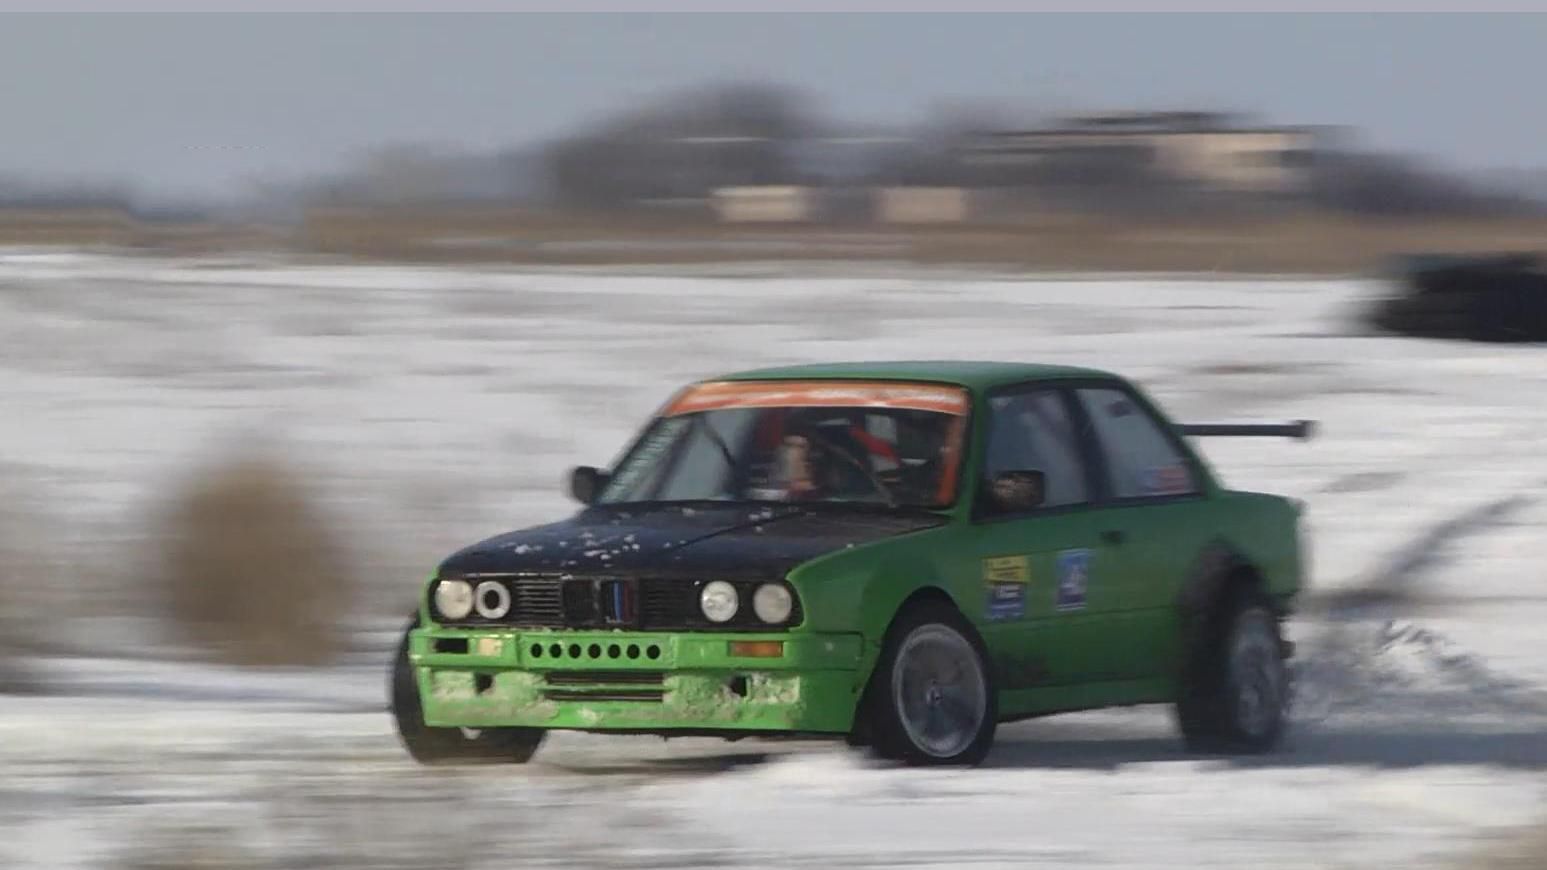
[0,252,1547,868]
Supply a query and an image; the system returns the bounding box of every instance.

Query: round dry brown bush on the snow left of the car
[159,452,354,667]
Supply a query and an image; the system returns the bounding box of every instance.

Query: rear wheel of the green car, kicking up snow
[1176,590,1290,754]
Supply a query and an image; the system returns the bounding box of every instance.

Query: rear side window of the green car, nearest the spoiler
[1078,389,1197,498]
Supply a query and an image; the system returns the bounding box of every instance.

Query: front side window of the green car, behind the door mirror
[984,390,1091,508]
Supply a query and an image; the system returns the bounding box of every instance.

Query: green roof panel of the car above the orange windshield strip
[715,359,1120,392]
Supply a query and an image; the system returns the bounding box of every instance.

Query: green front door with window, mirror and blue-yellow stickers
[973,384,1118,693]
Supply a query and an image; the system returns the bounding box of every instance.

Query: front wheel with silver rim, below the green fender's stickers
[849,602,999,766]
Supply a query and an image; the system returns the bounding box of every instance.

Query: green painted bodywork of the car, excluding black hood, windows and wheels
[408,362,1304,735]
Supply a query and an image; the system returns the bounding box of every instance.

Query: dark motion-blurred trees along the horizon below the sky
[0,82,1547,217]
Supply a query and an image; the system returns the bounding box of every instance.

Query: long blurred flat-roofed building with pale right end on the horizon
[962,111,1320,194]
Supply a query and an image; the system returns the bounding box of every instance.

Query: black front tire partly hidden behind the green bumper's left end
[391,618,546,765]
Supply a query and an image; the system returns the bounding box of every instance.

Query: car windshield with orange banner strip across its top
[599,381,968,508]
